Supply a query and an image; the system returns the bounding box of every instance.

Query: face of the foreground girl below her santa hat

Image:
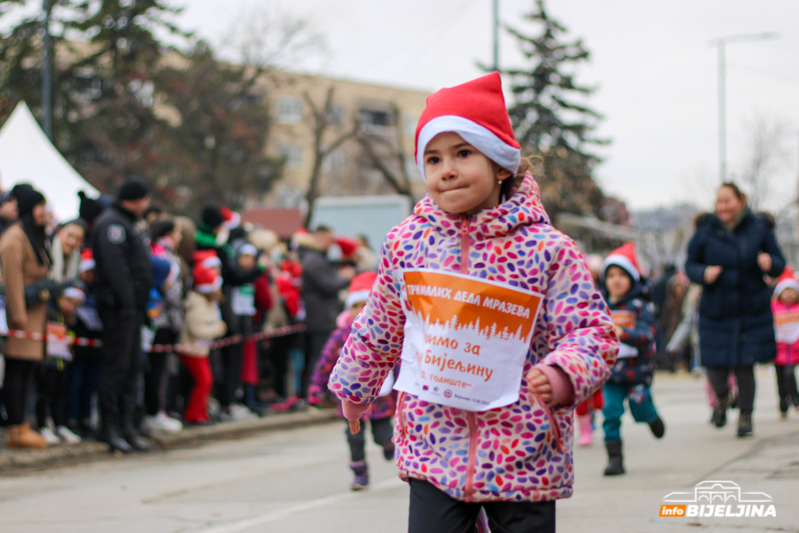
[424,132,511,215]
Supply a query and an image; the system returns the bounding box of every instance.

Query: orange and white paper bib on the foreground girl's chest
[394,270,544,411]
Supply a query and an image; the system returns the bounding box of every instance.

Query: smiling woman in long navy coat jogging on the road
[685,183,785,437]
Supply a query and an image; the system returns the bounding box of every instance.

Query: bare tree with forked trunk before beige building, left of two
[303,87,358,228]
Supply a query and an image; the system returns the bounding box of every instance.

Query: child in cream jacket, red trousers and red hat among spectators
[178,266,227,425]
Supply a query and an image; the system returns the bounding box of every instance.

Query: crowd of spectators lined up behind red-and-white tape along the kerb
[0,179,377,453]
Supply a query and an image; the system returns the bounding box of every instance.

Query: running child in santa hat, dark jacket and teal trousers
[602,243,666,476]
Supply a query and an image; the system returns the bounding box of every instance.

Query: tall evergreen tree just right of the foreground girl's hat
[502,0,608,218]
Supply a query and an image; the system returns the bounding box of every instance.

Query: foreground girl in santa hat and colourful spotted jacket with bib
[329,73,618,533]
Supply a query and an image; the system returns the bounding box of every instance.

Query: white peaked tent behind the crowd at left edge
[0,102,100,220]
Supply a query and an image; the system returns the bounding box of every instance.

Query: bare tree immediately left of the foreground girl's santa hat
[357,104,416,203]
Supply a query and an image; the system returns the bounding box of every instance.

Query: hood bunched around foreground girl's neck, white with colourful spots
[413,174,551,239]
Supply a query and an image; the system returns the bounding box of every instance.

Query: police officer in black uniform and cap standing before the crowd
[91,178,152,453]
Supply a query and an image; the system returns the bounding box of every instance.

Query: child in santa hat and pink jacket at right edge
[771,266,799,420]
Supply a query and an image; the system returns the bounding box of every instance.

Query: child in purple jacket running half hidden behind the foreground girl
[308,272,396,490]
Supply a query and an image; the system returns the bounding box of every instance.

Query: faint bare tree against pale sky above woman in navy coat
[740,115,791,209]
